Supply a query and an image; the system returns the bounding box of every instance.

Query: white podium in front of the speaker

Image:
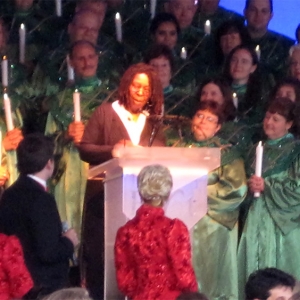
[89,147,220,300]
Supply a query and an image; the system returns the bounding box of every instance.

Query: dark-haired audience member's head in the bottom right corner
[245,268,295,300]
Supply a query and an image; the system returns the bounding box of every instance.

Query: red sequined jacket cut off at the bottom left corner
[0,233,33,300]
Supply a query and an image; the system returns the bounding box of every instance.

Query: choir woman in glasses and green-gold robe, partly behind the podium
[177,100,247,300]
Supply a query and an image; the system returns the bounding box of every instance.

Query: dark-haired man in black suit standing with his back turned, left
[0,134,78,294]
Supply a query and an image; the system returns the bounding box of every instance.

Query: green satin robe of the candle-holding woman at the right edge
[238,134,300,299]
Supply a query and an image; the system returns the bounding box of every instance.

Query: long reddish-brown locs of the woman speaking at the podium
[118,63,163,115]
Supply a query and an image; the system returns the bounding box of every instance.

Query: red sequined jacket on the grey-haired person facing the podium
[115,204,197,300]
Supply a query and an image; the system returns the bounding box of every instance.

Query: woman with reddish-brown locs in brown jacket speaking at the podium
[79,63,165,165]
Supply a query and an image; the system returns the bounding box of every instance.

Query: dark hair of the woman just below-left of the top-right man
[215,20,251,64]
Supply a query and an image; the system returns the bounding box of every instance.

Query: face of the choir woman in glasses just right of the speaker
[192,110,221,141]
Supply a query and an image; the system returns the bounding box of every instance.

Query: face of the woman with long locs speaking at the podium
[129,73,151,113]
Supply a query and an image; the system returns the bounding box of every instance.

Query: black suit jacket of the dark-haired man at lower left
[0,175,74,293]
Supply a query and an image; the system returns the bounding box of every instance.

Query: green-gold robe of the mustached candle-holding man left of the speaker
[45,78,113,234]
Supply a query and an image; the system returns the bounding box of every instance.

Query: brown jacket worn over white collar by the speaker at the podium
[79,103,165,165]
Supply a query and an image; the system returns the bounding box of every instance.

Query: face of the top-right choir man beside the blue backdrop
[244,0,273,32]
